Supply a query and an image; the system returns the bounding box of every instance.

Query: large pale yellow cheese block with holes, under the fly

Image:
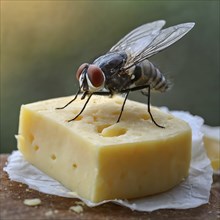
[17,96,191,202]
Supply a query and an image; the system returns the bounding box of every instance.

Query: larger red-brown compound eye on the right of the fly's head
[87,65,104,87]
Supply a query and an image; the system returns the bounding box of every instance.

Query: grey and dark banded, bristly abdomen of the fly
[133,60,169,92]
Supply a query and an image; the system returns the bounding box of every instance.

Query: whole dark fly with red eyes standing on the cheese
[57,20,194,128]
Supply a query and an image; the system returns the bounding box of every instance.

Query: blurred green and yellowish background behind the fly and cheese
[0,0,220,152]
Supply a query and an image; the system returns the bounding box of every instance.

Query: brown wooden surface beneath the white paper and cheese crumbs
[0,154,220,220]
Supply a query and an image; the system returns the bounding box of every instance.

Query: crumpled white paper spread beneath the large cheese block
[4,111,213,212]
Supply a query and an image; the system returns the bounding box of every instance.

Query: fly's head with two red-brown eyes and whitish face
[76,63,105,93]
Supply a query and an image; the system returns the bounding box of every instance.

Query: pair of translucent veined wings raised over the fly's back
[110,21,194,69]
